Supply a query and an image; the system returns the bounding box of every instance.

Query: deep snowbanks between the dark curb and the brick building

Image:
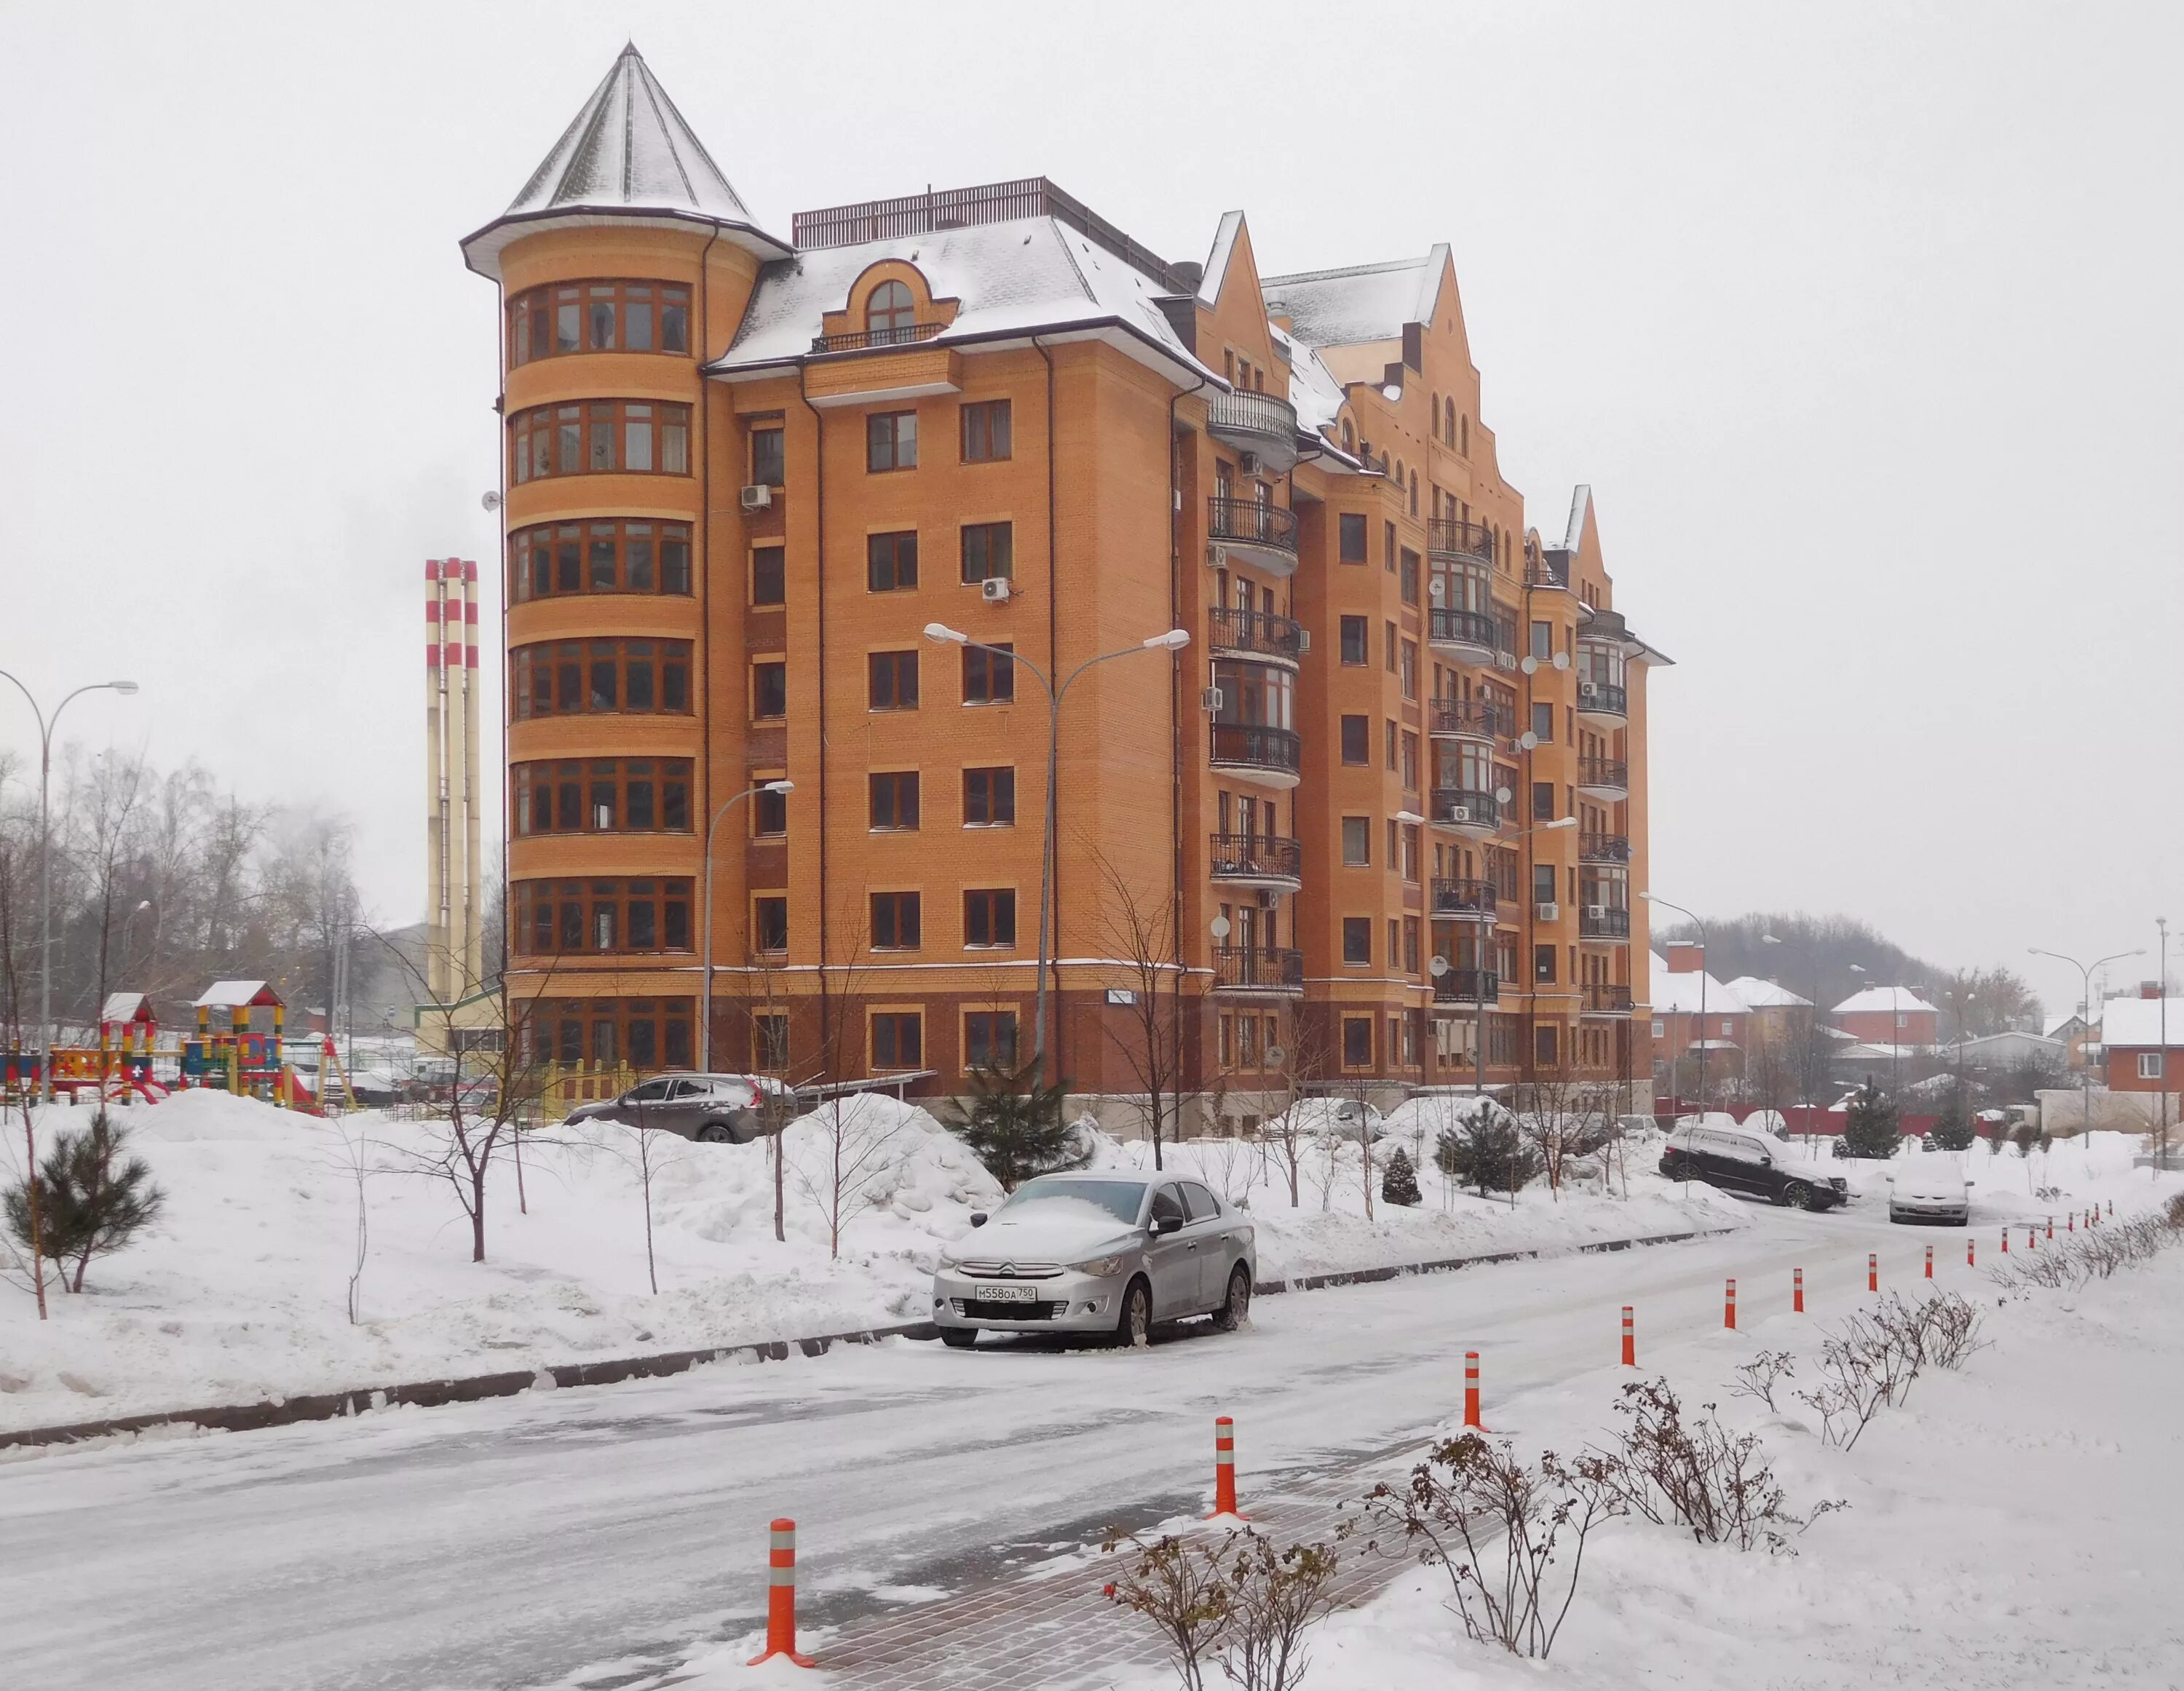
[0,1093,1745,1429]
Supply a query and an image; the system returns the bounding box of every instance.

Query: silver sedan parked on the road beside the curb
[933,1169,1258,1346]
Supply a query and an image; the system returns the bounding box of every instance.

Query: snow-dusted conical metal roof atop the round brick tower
[463,44,788,277]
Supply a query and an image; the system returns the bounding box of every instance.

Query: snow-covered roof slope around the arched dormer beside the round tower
[710,216,1225,387]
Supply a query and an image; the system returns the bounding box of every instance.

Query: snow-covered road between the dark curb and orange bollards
[0,1202,1966,1691]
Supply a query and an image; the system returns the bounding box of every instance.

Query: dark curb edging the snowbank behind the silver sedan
[0,1228,1736,1451]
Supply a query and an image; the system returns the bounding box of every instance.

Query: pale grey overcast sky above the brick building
[0,0,2184,1007]
